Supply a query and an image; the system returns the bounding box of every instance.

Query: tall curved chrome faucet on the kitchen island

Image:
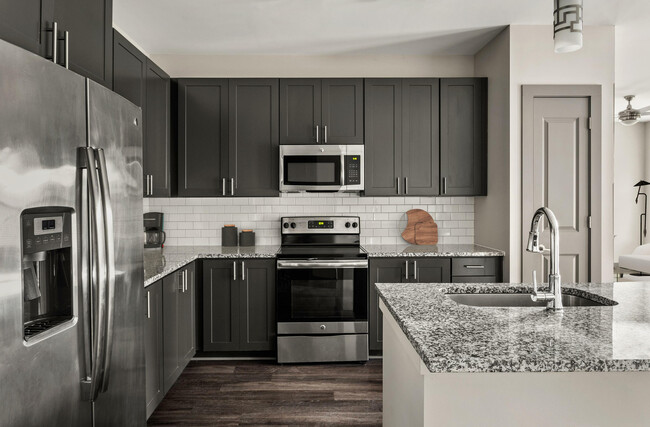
[526,207,563,311]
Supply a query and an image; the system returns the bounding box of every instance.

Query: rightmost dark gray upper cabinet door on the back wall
[440,78,487,196]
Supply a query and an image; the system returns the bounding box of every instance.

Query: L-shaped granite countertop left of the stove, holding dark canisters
[144,245,280,287]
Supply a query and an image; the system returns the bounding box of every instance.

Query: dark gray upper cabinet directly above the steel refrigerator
[0,0,113,88]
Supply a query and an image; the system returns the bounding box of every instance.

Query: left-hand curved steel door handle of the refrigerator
[82,147,108,401]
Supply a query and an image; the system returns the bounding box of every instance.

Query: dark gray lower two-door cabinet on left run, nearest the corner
[163,264,196,393]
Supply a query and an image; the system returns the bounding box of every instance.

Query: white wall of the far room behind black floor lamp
[614,123,650,261]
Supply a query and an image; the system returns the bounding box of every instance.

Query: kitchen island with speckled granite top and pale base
[376,282,650,426]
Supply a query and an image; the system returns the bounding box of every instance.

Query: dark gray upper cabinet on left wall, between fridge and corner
[113,31,171,197]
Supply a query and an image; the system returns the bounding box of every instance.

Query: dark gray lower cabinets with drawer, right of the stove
[368,257,503,352]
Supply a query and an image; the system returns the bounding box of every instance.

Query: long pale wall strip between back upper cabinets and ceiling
[151,55,474,77]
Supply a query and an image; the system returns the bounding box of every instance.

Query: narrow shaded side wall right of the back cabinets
[474,28,511,281]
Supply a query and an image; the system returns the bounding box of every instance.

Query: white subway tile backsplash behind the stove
[143,193,474,246]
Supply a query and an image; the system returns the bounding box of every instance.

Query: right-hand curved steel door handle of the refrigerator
[96,148,115,391]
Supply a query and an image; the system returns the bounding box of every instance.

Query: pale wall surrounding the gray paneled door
[509,25,614,281]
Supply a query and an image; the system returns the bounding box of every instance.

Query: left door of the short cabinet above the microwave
[280,79,323,144]
